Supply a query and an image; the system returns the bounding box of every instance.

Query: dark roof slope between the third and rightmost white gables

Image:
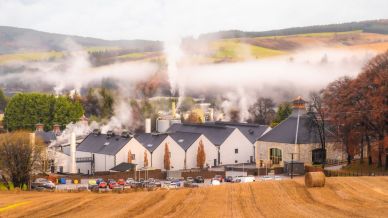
[167,123,235,146]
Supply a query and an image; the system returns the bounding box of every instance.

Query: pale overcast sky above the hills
[0,0,388,40]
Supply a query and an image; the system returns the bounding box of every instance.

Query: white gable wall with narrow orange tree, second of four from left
[152,136,185,170]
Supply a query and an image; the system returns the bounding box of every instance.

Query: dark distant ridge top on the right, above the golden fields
[199,19,388,40]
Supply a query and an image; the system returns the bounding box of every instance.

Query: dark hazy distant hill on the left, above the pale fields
[0,26,162,54]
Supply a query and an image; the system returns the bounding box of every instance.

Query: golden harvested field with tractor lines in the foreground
[0,177,388,218]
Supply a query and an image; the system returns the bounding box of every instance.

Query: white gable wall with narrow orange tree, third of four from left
[186,135,218,169]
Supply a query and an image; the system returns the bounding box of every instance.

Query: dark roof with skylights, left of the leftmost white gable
[77,133,131,155]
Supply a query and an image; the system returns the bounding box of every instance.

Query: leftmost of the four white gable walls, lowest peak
[116,138,151,168]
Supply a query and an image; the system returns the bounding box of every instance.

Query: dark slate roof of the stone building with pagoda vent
[258,110,319,144]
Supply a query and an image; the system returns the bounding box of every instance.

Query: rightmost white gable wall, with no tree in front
[220,129,254,165]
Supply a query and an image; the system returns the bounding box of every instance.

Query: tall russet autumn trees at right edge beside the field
[324,51,388,168]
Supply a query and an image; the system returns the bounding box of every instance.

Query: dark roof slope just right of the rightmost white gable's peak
[215,122,269,144]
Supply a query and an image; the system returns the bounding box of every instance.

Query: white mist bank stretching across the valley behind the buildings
[0,37,374,132]
